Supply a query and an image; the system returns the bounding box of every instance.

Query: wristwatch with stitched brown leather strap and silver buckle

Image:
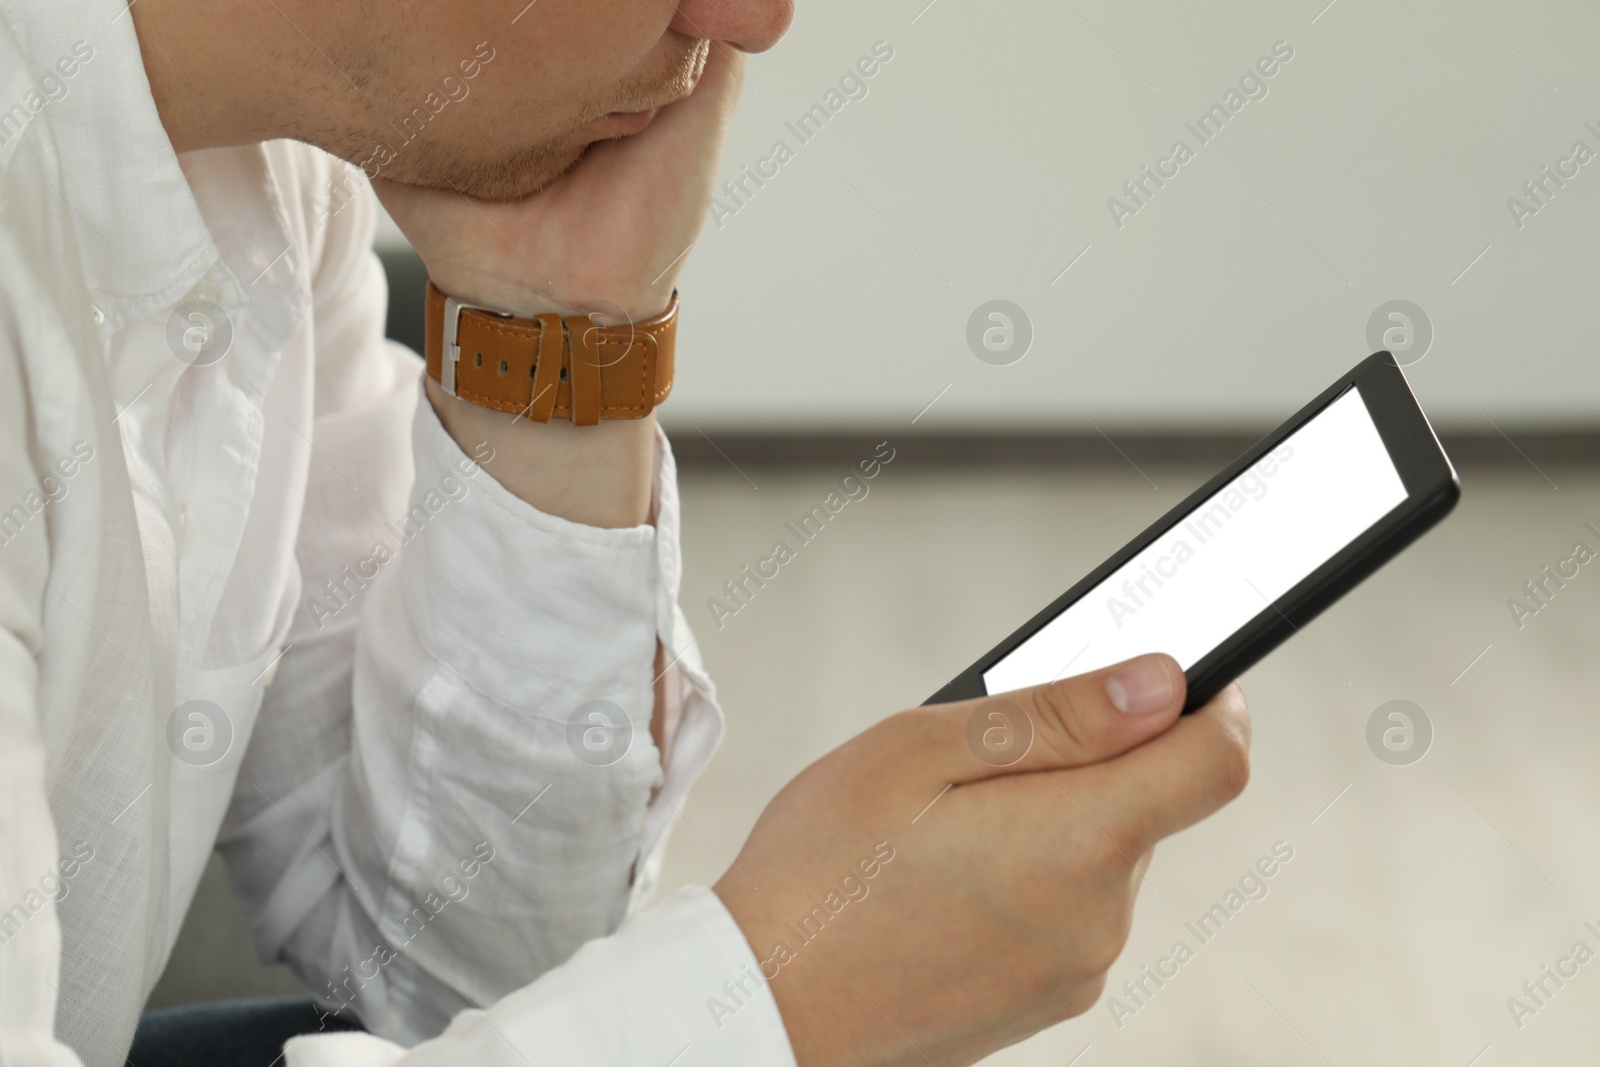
[424,282,678,426]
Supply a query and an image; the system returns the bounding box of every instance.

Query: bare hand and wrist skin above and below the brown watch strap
[373,43,744,526]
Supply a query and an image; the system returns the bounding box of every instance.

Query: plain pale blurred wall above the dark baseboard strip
[384,0,1600,432]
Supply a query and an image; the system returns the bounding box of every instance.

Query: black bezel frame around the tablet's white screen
[926,352,1461,712]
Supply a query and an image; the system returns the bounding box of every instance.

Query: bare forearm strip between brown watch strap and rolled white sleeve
[427,379,656,528]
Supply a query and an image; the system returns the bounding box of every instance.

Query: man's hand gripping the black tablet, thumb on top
[715,656,1250,1067]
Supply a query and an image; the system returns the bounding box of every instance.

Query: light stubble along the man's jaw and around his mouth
[377,37,710,200]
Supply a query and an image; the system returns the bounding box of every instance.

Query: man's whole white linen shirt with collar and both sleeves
[0,0,794,1067]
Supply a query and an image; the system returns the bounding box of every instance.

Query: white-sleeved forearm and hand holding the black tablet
[272,656,1250,1067]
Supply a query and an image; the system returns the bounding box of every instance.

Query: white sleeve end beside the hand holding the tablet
[286,886,795,1067]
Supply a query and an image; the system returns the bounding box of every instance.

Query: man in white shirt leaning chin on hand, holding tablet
[0,0,1248,1065]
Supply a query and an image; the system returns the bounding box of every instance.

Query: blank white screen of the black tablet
[984,389,1406,693]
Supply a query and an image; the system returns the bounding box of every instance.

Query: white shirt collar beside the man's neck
[0,0,243,336]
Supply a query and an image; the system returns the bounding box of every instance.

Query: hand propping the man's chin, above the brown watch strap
[373,43,744,322]
